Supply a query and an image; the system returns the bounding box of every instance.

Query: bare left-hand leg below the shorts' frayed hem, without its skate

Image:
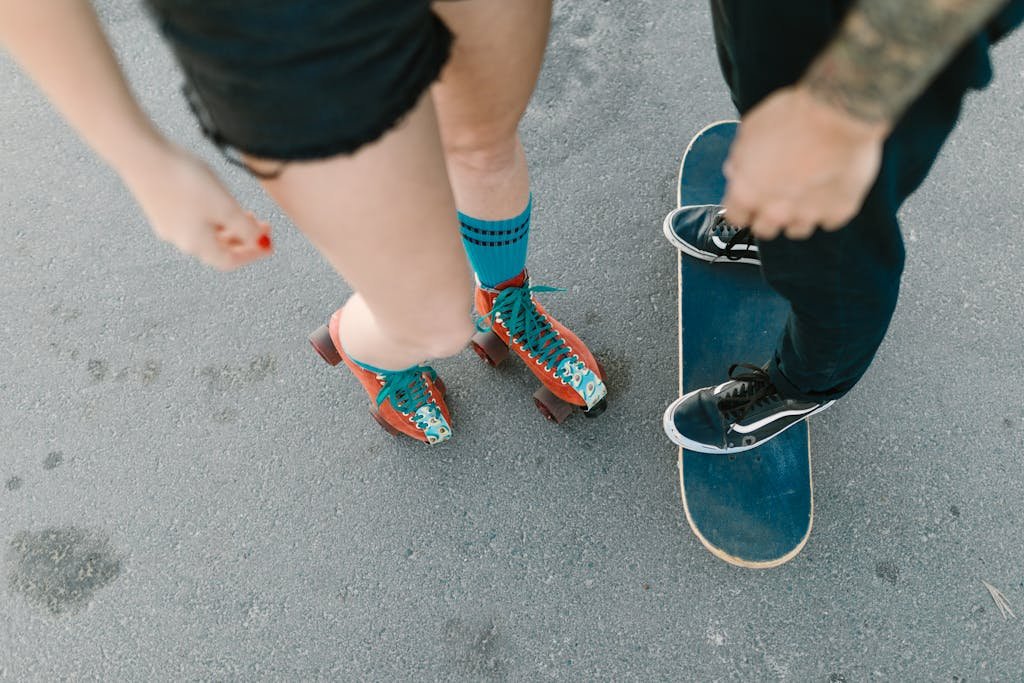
[254,94,473,370]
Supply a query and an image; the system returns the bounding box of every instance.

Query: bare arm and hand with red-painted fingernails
[0,0,270,270]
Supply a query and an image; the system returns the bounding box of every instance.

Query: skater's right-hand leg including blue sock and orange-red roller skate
[433,0,607,422]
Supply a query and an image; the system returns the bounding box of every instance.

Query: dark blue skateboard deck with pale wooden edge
[678,121,814,568]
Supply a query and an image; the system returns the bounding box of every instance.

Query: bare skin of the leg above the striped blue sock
[433,0,551,220]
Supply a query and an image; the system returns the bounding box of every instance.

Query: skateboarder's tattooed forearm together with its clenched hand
[724,0,1007,240]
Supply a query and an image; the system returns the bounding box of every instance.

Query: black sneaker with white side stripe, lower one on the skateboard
[663,362,836,454]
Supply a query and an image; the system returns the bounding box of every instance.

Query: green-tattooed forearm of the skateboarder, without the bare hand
[803,0,1007,123]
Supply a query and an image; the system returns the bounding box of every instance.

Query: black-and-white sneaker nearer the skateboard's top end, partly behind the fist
[664,204,761,265]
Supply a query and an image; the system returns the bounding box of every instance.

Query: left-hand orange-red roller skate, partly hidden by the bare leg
[309,310,452,443]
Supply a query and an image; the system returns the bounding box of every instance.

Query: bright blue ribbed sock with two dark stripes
[459,195,534,287]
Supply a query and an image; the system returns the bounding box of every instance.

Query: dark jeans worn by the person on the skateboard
[712,0,1024,401]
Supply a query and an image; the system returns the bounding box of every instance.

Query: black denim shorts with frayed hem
[148,0,452,169]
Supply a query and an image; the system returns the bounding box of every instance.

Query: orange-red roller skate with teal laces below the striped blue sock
[471,270,607,424]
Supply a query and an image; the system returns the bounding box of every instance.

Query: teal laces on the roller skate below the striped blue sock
[476,286,569,372]
